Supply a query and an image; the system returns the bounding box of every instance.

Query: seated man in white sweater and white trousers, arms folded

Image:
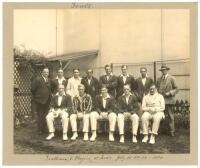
[142,84,165,144]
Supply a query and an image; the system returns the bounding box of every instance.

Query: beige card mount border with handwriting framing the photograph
[3,2,198,165]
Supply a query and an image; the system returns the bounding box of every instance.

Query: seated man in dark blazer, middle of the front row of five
[90,86,117,141]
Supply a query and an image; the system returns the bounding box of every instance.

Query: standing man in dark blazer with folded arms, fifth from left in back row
[99,65,117,98]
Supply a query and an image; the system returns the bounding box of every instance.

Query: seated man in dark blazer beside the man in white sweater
[117,85,139,143]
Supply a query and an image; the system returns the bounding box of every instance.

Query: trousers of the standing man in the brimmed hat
[165,104,175,133]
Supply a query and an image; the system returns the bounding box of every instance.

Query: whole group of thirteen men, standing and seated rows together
[31,64,178,144]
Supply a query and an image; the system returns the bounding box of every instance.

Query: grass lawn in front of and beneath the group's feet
[14,121,190,154]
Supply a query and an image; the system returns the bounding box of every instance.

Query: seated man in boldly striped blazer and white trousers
[70,84,92,141]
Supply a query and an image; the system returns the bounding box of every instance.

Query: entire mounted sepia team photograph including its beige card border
[4,3,197,164]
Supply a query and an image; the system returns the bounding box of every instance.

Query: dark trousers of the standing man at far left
[36,101,49,133]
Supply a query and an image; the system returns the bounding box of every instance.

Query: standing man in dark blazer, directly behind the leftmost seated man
[51,69,67,95]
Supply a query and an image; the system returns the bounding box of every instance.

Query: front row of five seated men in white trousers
[46,84,165,144]
